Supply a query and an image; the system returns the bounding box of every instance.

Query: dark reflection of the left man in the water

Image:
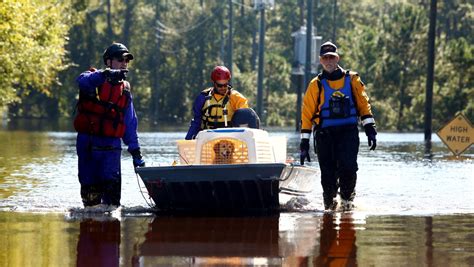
[76,218,120,267]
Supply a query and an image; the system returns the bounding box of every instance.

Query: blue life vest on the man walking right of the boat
[320,72,358,128]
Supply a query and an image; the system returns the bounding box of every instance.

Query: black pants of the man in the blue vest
[314,125,359,200]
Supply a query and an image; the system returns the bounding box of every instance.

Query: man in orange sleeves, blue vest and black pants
[300,42,377,210]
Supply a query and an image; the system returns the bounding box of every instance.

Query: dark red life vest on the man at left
[74,81,130,138]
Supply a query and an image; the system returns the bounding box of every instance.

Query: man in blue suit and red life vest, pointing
[74,43,145,207]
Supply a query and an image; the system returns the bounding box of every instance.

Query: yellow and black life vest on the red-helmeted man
[201,88,234,129]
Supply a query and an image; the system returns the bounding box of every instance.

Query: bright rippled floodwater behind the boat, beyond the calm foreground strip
[0,132,474,215]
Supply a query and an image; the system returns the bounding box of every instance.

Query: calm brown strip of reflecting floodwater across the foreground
[0,212,474,266]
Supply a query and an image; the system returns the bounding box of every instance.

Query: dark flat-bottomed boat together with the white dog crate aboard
[135,128,318,213]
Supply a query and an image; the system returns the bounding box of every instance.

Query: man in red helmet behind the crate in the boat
[186,66,249,140]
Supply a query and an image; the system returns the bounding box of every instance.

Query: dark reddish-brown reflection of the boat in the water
[134,216,281,266]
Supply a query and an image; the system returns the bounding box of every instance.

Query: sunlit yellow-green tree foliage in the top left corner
[0,0,70,110]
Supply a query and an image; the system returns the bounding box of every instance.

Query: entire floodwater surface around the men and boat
[0,122,474,266]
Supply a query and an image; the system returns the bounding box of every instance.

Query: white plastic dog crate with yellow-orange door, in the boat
[178,128,286,165]
